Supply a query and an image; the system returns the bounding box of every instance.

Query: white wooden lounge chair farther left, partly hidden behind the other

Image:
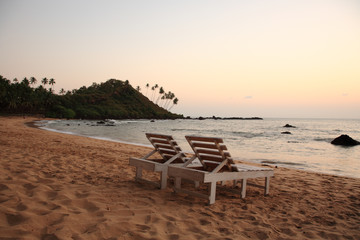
[129,133,193,189]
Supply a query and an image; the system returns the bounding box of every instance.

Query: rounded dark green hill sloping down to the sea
[46,79,183,119]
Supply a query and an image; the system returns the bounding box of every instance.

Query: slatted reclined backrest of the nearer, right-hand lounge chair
[185,136,234,172]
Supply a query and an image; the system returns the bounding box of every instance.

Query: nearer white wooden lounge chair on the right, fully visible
[168,136,274,204]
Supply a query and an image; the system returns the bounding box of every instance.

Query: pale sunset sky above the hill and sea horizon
[0,0,360,118]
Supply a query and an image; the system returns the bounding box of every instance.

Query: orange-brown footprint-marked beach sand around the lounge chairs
[0,117,360,239]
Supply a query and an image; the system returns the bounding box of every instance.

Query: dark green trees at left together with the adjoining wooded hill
[0,76,183,119]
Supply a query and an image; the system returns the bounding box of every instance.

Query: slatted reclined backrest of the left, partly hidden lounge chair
[145,133,186,163]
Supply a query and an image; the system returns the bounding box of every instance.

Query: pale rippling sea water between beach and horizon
[41,119,360,178]
